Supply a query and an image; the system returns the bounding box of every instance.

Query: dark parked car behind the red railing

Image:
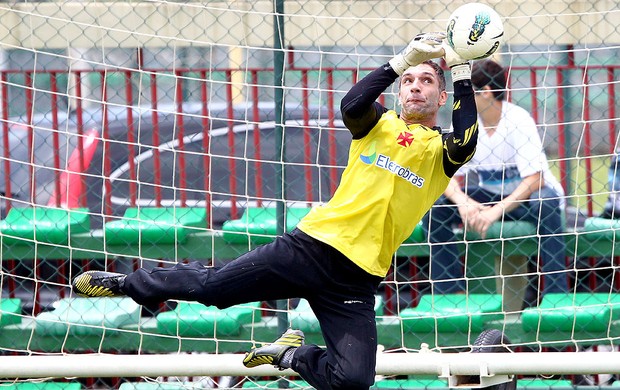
[0,103,351,228]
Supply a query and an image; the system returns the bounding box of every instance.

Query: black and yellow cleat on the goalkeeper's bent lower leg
[243,329,304,369]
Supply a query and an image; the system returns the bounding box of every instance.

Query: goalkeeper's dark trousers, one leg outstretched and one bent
[124,229,382,390]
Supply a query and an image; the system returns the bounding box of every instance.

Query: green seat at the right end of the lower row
[521,293,620,332]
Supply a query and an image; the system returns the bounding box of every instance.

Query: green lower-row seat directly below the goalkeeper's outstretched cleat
[35,297,140,336]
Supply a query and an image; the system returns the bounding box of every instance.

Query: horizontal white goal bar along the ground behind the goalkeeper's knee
[0,352,620,379]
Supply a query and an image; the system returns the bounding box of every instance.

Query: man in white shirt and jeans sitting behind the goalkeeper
[424,60,568,304]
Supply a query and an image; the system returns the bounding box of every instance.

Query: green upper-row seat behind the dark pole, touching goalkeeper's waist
[222,207,310,244]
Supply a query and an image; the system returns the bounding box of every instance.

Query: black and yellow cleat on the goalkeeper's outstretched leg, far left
[71,271,127,298]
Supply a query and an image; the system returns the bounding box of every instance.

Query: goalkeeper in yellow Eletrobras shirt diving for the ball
[73,33,478,389]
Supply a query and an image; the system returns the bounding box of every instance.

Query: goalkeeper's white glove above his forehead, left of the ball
[388,32,446,76]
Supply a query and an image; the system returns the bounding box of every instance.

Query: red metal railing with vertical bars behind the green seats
[0,65,618,221]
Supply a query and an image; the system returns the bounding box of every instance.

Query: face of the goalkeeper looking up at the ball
[398,64,448,126]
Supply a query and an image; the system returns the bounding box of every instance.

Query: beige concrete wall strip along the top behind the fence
[0,0,620,49]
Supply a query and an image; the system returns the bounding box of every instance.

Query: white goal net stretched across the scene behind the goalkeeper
[0,0,620,389]
